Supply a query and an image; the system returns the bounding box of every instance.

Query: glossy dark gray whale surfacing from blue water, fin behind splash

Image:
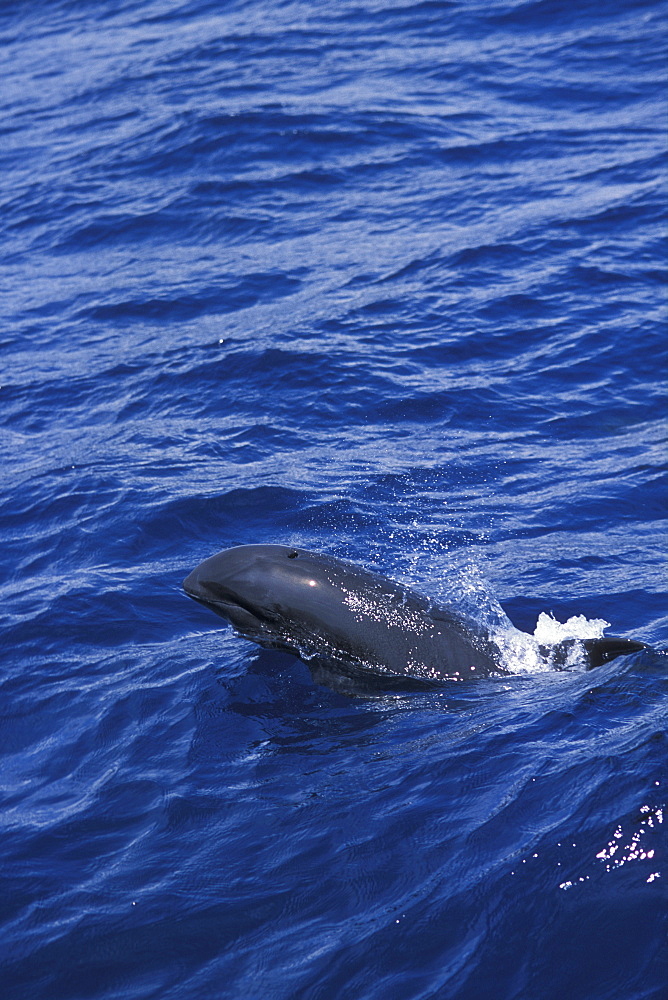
[183,545,645,687]
